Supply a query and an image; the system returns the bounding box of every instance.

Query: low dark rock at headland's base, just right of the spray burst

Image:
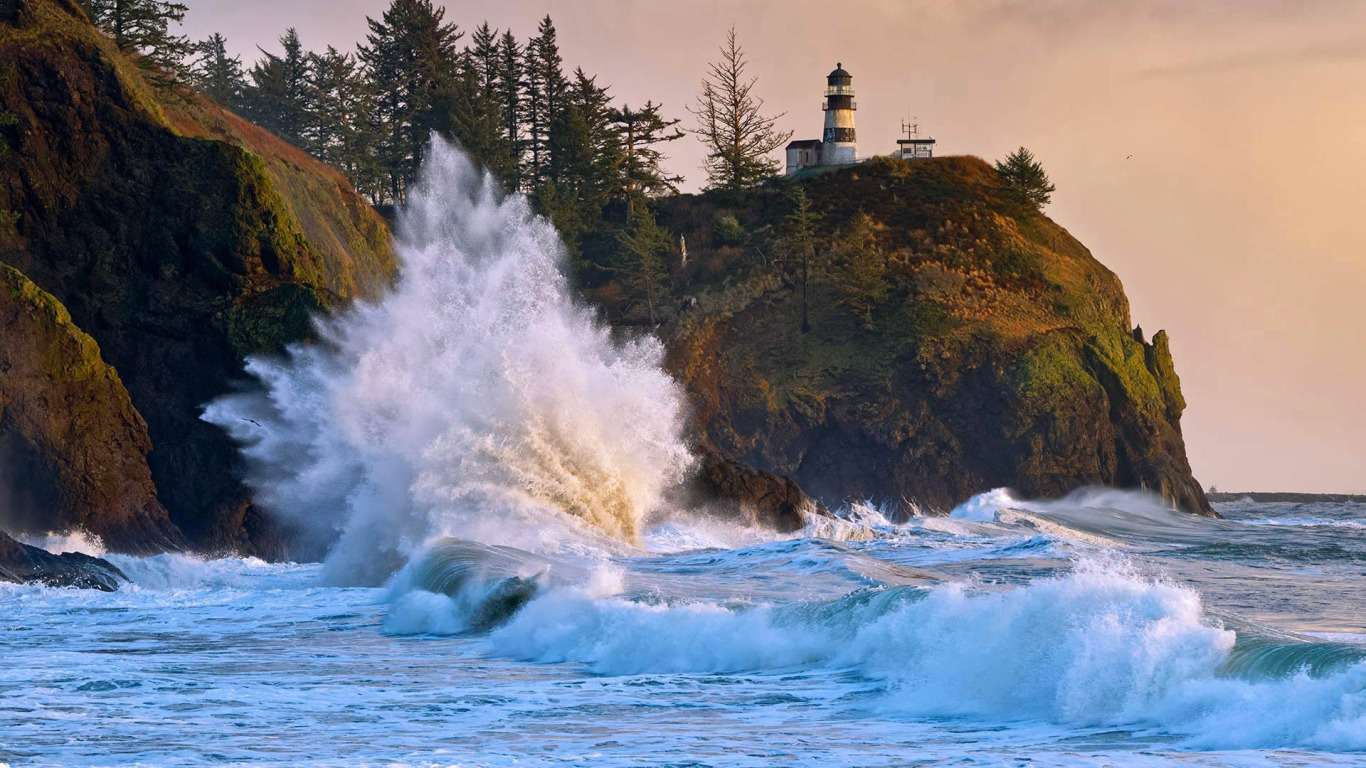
[695,451,826,533]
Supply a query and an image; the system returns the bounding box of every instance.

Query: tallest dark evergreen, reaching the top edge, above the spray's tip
[359,0,464,202]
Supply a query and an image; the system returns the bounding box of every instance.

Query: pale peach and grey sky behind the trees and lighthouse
[186,0,1366,492]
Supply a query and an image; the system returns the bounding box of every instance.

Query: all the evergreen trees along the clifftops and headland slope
[72,0,1053,332]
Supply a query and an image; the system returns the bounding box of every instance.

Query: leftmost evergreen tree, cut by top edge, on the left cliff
[82,0,191,86]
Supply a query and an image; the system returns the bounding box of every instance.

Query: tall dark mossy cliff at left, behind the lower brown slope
[0,0,395,555]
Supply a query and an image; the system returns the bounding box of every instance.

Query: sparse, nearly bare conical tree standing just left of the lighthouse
[688,27,792,190]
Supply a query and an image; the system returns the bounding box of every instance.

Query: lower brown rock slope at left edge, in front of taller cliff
[0,264,184,553]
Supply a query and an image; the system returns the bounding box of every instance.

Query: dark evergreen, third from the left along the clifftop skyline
[243,27,313,149]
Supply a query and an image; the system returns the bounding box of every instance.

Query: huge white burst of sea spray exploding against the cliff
[205,139,691,584]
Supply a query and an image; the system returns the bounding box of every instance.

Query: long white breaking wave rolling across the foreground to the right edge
[385,543,1366,749]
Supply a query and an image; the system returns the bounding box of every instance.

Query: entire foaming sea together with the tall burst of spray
[0,143,1366,767]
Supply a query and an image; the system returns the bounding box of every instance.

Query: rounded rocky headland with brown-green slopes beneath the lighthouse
[589,157,1212,514]
